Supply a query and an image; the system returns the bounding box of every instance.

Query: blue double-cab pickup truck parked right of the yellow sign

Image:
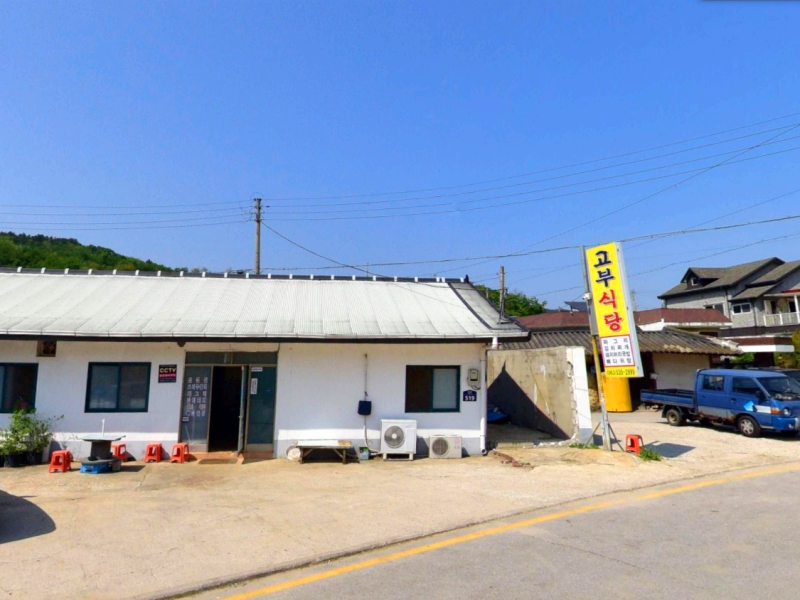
[642,369,800,437]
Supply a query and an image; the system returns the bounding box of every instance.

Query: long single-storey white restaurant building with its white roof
[0,269,528,457]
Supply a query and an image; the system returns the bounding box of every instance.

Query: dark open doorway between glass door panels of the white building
[208,367,242,452]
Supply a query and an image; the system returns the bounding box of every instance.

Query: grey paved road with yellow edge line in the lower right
[192,470,800,600]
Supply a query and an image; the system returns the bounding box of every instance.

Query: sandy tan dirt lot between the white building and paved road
[0,412,800,600]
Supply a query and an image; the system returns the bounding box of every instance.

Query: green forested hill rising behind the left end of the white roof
[0,231,172,271]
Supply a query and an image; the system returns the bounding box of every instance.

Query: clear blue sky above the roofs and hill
[0,1,800,307]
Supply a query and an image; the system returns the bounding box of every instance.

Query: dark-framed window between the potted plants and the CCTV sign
[86,363,150,412]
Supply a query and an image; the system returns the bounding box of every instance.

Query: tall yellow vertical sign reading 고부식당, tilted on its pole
[586,242,642,377]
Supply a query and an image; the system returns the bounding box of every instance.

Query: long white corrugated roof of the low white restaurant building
[0,272,528,340]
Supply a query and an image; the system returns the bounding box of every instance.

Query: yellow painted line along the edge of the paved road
[216,463,800,600]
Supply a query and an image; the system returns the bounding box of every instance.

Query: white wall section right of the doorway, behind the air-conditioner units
[275,344,486,456]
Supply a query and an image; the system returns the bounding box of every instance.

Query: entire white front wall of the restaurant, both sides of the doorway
[0,341,486,458]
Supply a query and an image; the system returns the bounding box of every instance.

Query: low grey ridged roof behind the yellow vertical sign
[503,328,741,355]
